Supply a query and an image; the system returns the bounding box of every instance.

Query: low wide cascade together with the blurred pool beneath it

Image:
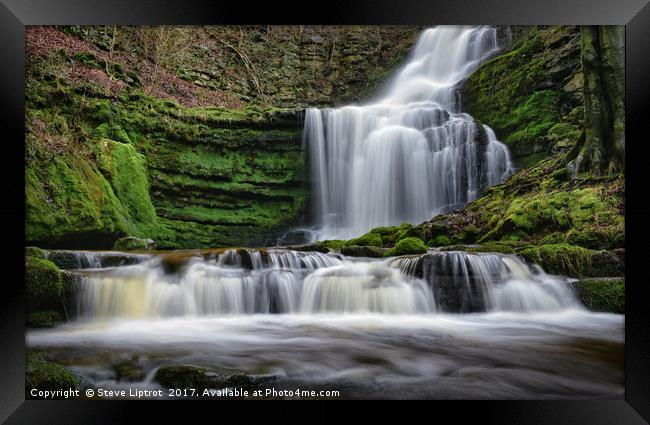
[27,249,624,398]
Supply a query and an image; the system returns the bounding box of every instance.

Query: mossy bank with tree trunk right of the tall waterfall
[321,26,625,277]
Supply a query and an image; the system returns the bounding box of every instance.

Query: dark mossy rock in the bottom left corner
[25,351,80,398]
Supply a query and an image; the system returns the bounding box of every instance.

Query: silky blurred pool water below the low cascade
[27,310,624,399]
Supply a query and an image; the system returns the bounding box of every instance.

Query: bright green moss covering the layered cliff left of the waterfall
[26,78,308,248]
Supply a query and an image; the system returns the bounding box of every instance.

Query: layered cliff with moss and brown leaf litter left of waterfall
[25,27,417,248]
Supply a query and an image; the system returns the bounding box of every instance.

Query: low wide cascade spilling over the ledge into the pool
[64,249,581,319]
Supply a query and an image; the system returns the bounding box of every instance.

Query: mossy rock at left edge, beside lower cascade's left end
[25,257,64,312]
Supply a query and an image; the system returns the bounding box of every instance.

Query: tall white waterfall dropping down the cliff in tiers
[304,26,512,239]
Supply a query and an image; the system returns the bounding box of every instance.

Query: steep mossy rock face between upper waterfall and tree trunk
[462,26,584,167]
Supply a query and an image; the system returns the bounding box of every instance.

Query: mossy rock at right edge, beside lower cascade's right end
[577,278,625,314]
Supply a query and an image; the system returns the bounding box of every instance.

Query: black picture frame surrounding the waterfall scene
[0,0,650,425]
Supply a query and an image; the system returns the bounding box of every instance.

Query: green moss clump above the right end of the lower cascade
[519,244,592,277]
